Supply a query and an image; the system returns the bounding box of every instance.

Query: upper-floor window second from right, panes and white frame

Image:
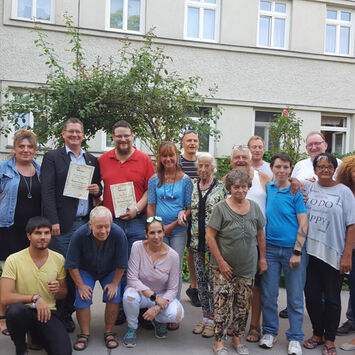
[258,1,289,49]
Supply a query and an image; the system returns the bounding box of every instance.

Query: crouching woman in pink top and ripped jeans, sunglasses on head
[123,216,184,348]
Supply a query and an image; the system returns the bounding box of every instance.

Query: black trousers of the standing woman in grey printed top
[304,255,343,341]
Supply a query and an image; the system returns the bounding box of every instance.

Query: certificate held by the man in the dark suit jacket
[63,162,95,200]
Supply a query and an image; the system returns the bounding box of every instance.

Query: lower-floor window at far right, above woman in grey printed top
[321,115,349,154]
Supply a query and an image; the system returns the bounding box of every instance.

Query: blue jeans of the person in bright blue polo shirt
[261,244,307,342]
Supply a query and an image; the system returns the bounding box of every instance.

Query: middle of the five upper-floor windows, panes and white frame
[185,0,220,42]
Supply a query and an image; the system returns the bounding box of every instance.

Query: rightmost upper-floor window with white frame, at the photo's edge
[325,9,353,55]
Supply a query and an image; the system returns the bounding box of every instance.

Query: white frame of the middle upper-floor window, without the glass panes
[184,0,221,43]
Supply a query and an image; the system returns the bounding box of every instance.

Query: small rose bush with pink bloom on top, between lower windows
[270,107,303,162]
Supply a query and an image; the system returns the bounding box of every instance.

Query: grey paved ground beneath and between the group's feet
[0,283,355,355]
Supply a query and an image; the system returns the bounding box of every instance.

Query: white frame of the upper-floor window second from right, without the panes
[256,0,291,50]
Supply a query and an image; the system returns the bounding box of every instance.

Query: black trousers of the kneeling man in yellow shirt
[6,303,72,355]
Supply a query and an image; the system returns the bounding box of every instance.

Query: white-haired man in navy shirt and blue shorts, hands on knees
[65,206,128,351]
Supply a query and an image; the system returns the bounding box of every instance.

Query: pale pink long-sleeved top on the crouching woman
[127,240,180,302]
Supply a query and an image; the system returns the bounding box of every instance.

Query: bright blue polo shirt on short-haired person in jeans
[265,182,307,248]
